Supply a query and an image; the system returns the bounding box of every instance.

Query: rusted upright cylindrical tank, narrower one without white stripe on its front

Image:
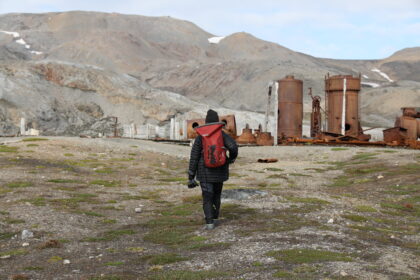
[277,75,303,138]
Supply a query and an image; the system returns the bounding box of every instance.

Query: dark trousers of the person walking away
[200,182,223,224]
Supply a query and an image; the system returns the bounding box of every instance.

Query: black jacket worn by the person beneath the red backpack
[188,132,238,183]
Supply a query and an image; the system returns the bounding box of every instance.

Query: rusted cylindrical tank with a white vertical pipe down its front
[325,75,360,137]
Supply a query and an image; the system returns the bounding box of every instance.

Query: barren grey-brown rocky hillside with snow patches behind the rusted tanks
[0,12,420,134]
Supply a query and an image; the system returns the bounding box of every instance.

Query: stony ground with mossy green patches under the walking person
[0,137,420,280]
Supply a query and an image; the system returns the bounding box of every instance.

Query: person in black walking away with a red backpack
[188,110,238,230]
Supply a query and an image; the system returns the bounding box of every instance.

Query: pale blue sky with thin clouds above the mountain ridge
[0,0,420,59]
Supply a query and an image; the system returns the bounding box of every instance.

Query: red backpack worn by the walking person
[195,123,226,168]
